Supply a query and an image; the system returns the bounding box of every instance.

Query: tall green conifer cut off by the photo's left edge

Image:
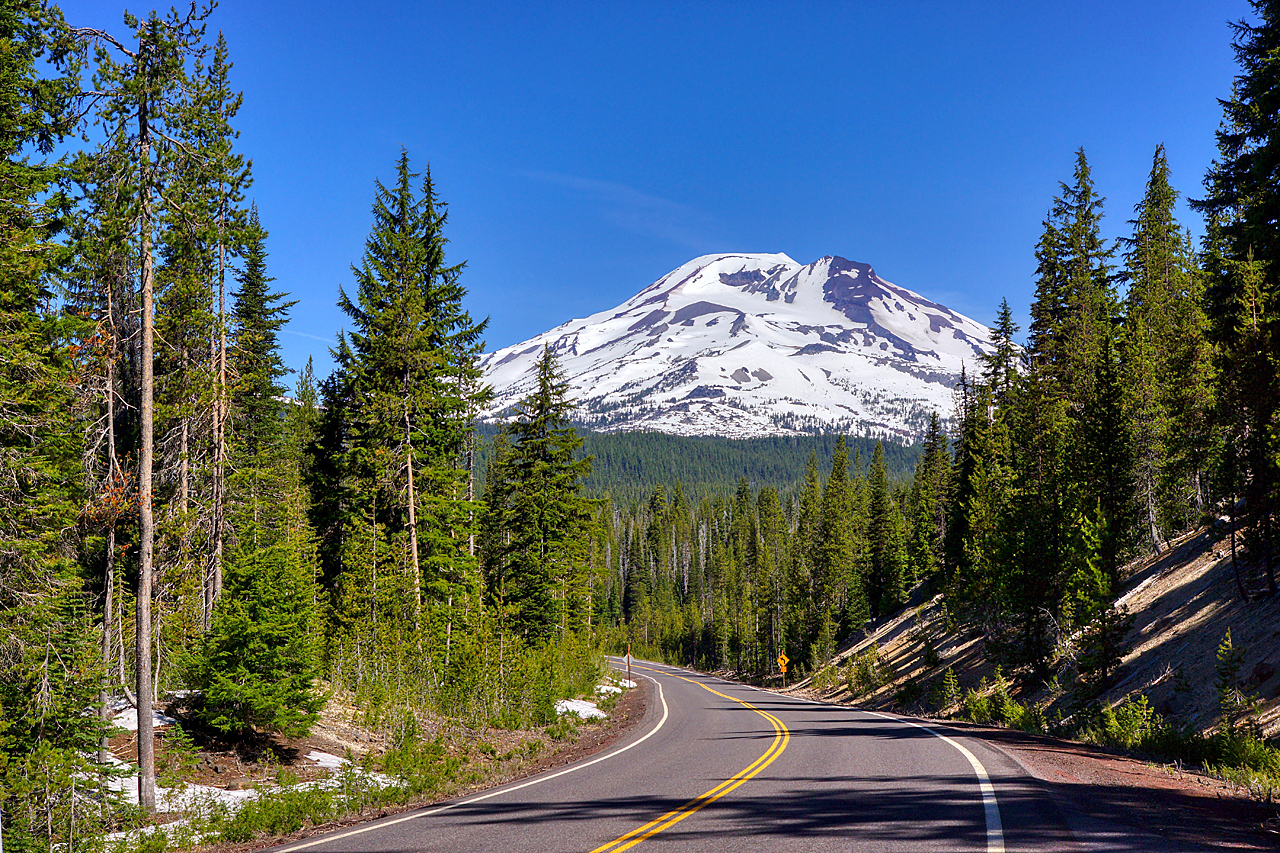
[0,3,102,783]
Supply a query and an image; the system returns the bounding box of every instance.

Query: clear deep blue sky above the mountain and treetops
[61,0,1248,375]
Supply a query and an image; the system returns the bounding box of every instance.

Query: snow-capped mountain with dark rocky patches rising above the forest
[480,255,993,438]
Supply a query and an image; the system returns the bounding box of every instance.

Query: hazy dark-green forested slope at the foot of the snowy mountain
[475,424,922,505]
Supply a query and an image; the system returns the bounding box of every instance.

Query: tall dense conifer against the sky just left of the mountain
[334,151,486,630]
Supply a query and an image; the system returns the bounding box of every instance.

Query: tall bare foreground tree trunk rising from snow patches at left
[134,91,156,815]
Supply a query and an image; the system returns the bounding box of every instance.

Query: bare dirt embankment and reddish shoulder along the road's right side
[787,530,1280,849]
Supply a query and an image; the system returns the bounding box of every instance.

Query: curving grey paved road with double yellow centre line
[267,663,1198,853]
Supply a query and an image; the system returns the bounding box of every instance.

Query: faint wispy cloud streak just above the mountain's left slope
[520,170,719,251]
